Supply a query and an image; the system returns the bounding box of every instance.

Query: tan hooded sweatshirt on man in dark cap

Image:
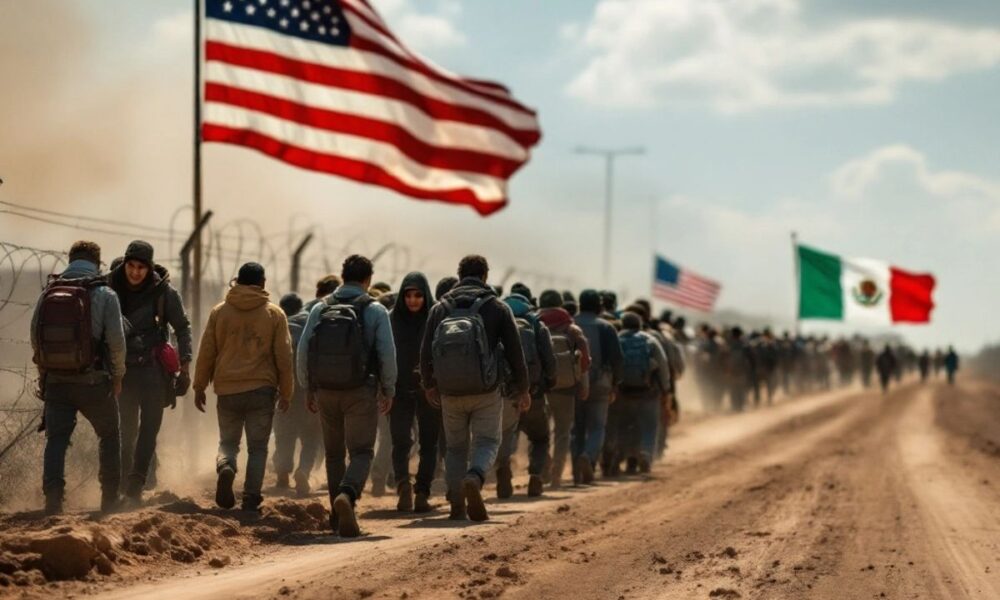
[194,285,295,401]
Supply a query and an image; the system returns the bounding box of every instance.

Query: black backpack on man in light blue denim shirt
[308,294,374,390]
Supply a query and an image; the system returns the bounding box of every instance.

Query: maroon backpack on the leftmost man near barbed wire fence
[34,277,107,373]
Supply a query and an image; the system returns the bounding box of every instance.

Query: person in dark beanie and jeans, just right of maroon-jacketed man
[571,289,622,485]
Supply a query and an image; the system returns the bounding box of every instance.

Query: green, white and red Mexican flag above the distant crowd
[796,245,934,325]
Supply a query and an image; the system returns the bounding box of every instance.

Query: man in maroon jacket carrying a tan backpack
[538,290,590,488]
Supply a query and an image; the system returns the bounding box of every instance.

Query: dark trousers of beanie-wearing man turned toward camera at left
[118,364,173,491]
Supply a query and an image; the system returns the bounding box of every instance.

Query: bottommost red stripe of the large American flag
[202,123,507,216]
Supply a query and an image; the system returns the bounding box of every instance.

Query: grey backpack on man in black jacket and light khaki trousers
[431,294,499,396]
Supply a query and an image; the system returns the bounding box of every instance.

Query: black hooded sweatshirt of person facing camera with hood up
[389,273,434,395]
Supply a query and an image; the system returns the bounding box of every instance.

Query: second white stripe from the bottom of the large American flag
[205,62,528,163]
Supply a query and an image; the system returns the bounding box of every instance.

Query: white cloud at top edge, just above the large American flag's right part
[375,0,468,52]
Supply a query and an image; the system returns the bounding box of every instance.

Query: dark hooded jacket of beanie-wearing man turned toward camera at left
[108,265,193,365]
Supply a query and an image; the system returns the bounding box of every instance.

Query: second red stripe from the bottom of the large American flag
[205,83,522,178]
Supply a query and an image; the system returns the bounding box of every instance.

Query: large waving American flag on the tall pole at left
[202,0,541,215]
